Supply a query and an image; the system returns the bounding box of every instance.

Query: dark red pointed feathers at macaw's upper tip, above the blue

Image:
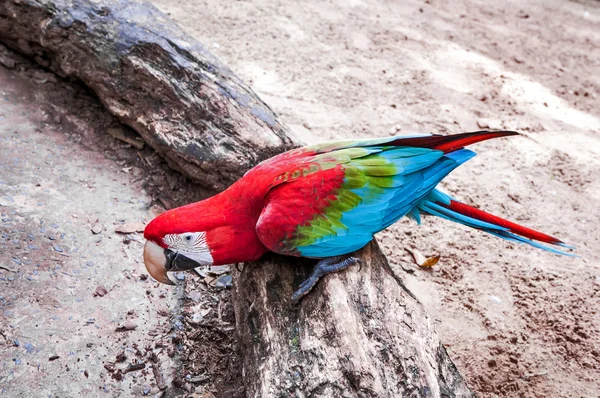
[391,131,519,153]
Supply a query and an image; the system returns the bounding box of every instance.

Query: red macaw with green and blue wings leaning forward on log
[144,131,571,301]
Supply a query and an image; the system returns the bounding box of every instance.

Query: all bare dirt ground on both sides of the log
[0,0,600,397]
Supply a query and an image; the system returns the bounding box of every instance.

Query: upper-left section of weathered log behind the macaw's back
[0,0,294,190]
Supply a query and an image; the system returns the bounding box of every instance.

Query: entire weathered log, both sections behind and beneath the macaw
[0,0,473,397]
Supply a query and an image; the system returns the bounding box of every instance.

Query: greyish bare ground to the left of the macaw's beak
[0,46,209,397]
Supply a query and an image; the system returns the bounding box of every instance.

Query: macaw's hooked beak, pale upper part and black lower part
[144,240,200,285]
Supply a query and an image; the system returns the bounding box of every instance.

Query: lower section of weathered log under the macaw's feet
[234,242,473,397]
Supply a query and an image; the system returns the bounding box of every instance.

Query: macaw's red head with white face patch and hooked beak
[144,202,218,285]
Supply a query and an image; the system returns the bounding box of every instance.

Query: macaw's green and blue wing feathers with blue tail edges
[264,134,573,258]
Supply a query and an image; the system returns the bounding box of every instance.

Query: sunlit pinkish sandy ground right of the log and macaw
[148,0,600,397]
